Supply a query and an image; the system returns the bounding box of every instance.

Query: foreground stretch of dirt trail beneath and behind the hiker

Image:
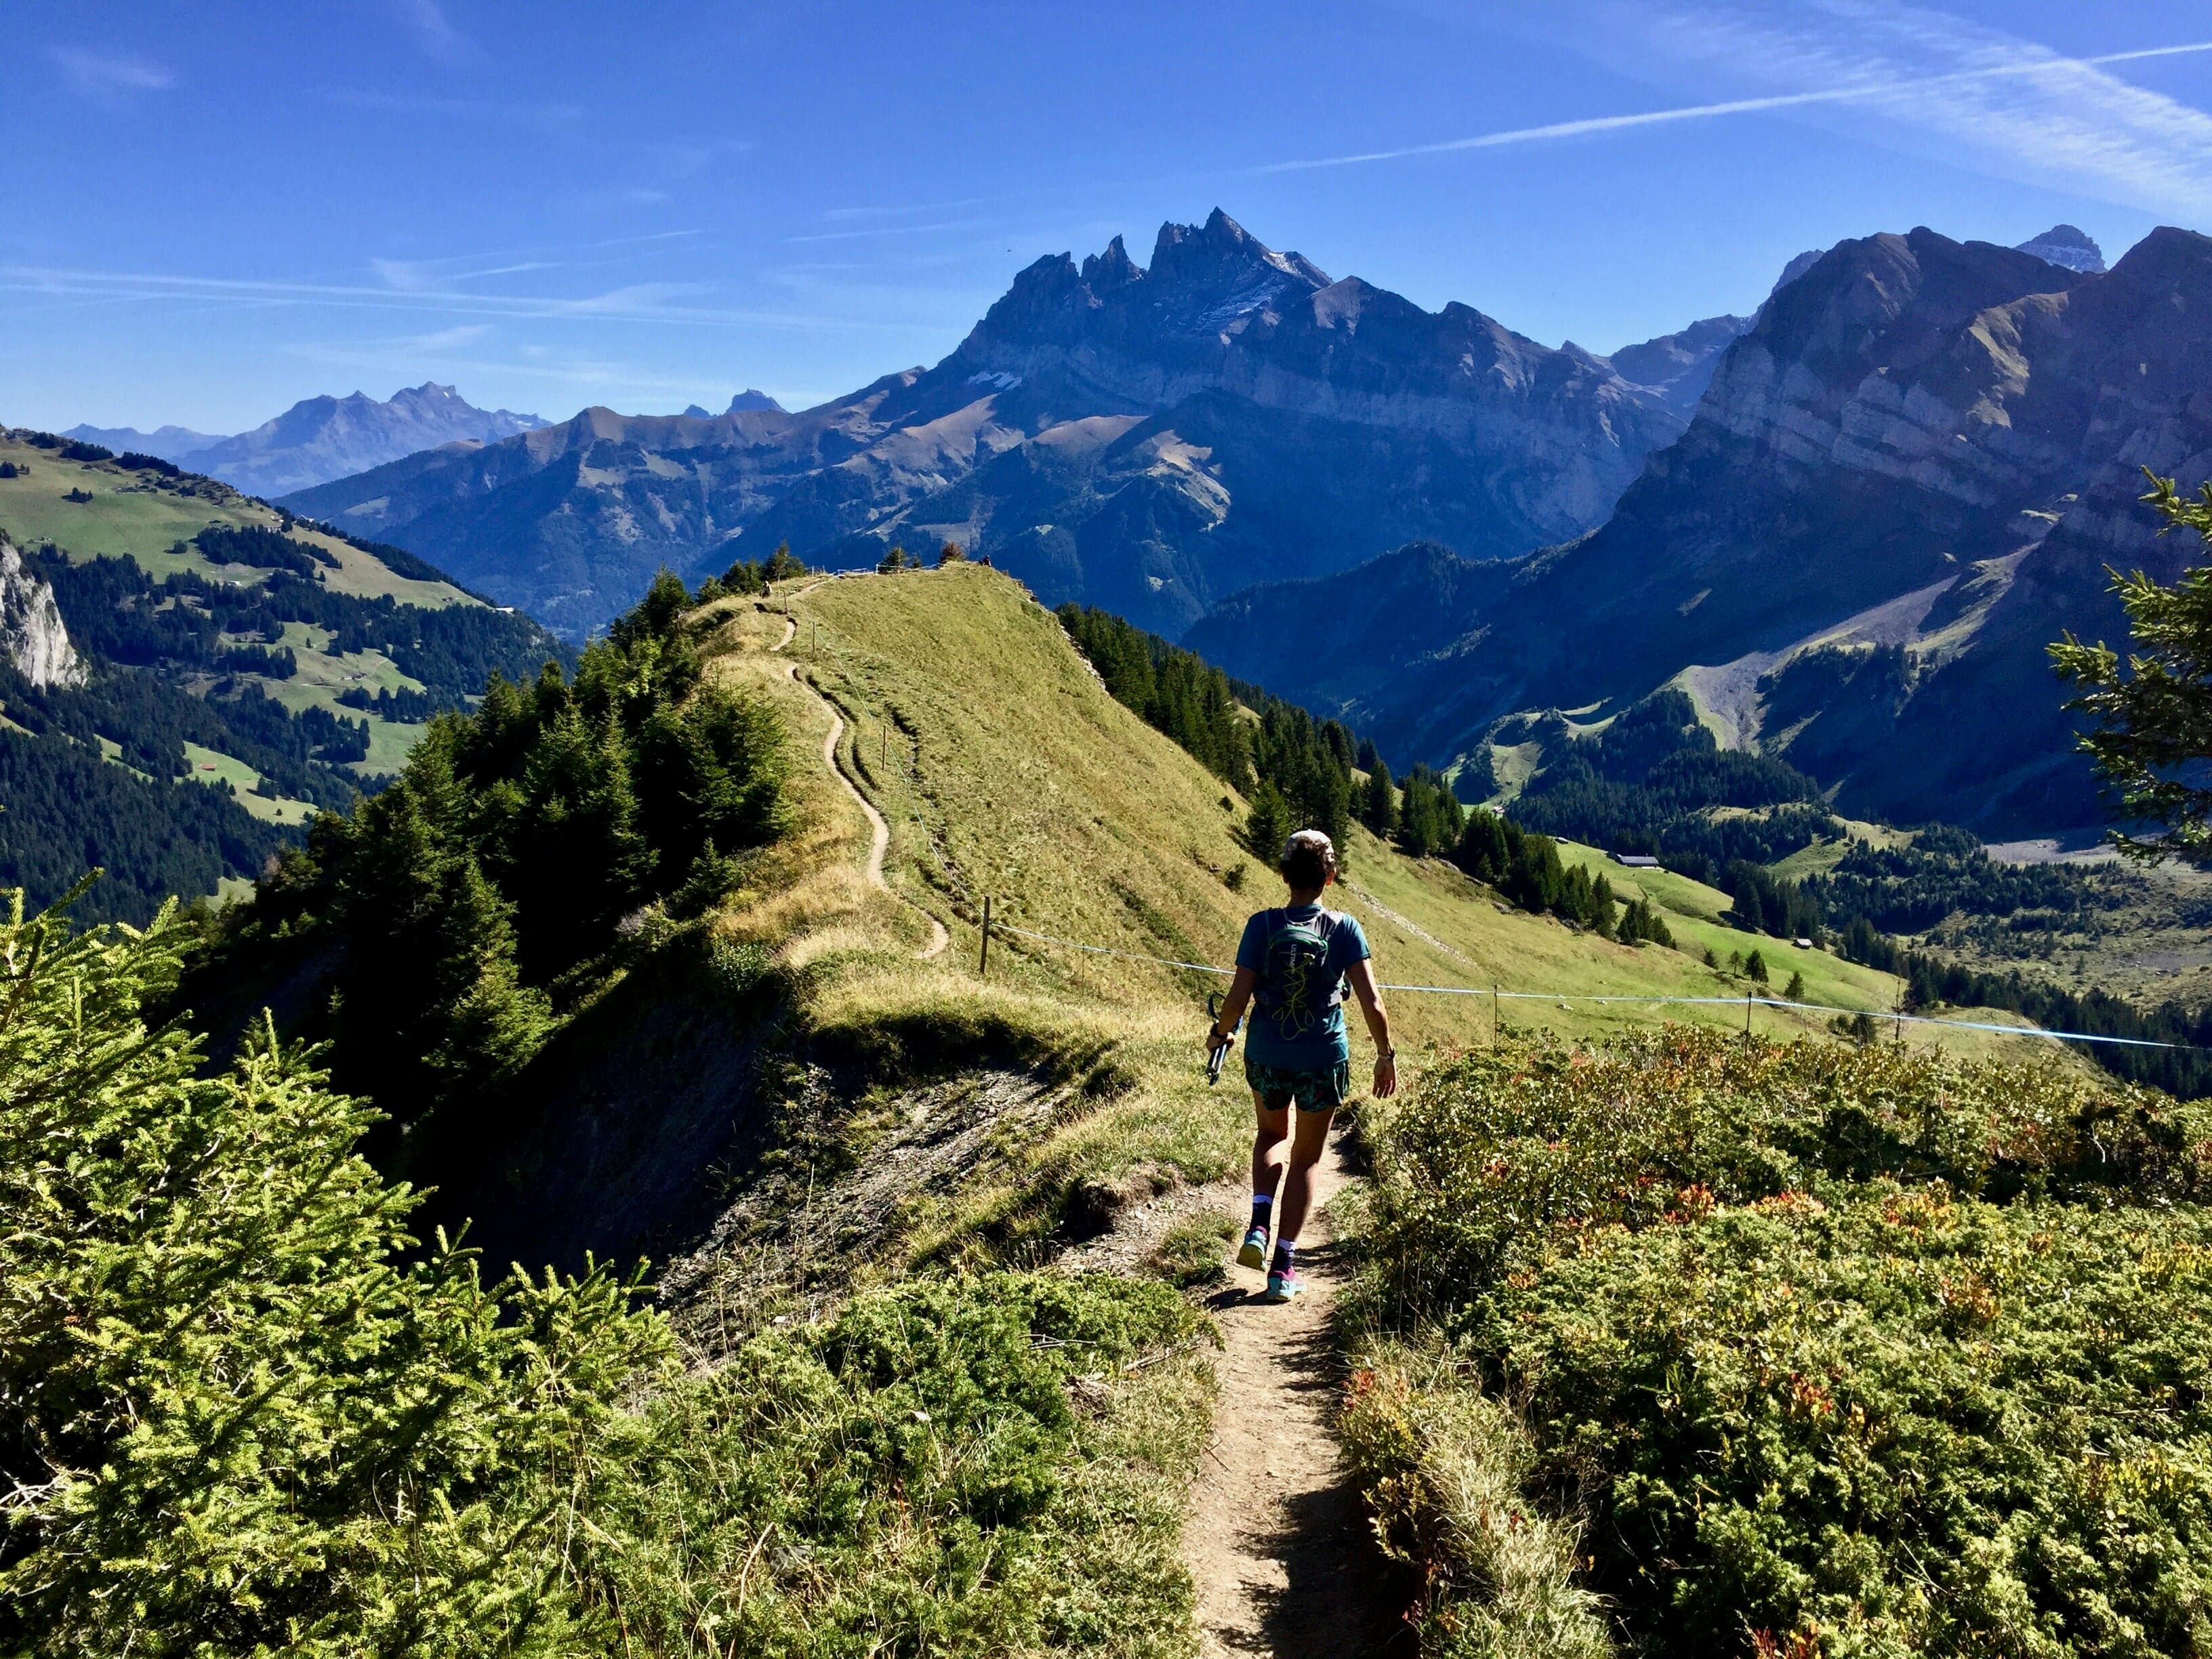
[1183,1143,1414,1659]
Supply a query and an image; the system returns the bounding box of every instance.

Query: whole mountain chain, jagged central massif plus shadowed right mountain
[263,210,2176,834]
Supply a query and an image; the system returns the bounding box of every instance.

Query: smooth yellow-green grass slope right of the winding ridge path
[710,567,2070,1064]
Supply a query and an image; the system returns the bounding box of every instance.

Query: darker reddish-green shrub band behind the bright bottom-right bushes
[1365,1026,2212,1318]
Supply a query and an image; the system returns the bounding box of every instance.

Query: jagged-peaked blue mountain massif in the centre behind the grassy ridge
[290,210,1750,635]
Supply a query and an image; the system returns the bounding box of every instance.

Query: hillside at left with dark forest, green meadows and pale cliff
[0,431,571,922]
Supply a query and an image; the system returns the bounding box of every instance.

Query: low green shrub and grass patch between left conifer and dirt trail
[600,1274,1206,1659]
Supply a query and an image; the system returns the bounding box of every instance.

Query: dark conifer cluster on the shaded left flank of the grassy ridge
[186,573,783,1159]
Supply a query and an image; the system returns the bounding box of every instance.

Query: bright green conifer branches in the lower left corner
[0,878,672,1659]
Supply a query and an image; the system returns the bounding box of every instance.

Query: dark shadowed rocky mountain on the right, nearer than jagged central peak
[1188,230,2185,838]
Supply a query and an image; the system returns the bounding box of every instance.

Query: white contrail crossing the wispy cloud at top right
[1250,13,2212,210]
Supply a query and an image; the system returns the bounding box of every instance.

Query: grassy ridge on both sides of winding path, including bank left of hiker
[670,567,2070,1307]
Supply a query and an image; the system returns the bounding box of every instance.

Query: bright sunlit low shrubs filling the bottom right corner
[1495,1181,2212,1659]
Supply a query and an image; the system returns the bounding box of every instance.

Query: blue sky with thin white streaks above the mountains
[0,0,2212,431]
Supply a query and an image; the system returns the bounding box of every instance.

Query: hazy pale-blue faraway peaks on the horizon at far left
[62,380,544,495]
